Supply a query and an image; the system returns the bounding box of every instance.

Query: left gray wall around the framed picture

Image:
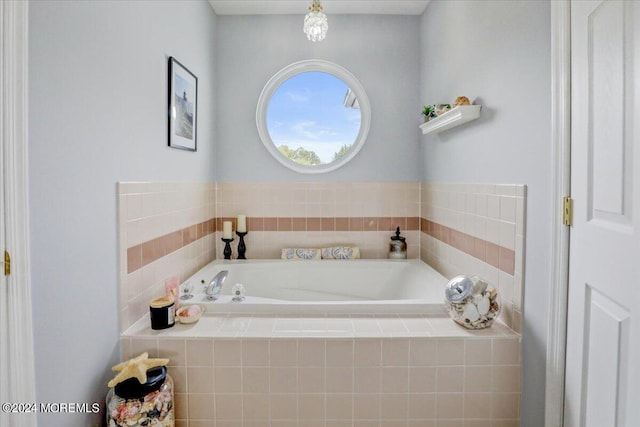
[29,1,216,427]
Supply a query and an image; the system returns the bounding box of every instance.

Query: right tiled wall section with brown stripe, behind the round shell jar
[420,183,526,332]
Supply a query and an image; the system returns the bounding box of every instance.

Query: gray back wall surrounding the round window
[216,15,420,181]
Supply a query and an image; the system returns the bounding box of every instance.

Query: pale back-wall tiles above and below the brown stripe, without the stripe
[216,182,420,258]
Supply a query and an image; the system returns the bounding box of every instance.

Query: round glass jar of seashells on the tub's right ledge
[444,275,501,329]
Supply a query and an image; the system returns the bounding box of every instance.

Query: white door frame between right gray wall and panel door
[545,0,571,427]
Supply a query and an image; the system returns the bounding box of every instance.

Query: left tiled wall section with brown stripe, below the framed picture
[117,182,216,331]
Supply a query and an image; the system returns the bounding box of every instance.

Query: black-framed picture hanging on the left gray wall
[168,57,198,151]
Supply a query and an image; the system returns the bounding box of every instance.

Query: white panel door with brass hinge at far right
[565,0,640,427]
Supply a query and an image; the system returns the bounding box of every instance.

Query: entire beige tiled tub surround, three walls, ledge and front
[119,183,525,427]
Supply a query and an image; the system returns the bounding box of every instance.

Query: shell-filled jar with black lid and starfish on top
[106,353,175,427]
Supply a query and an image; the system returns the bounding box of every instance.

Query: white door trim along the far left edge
[0,1,36,427]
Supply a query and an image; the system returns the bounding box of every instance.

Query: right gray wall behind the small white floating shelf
[420,1,552,427]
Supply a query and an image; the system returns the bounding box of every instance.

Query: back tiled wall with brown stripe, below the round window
[216,182,420,259]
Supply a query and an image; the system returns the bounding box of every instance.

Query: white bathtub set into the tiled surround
[181,260,447,314]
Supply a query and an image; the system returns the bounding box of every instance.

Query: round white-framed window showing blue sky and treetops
[256,60,371,173]
